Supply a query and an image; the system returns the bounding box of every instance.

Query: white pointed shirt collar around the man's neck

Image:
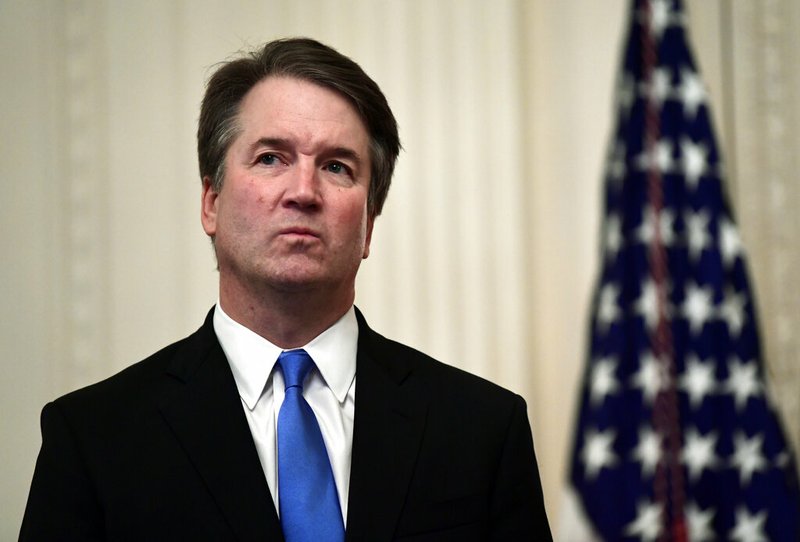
[214,303,358,410]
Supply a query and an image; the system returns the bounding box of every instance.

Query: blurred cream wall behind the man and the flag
[0,0,800,540]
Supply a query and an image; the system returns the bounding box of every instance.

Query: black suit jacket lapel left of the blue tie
[160,311,283,540]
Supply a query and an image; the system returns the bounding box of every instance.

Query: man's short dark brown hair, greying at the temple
[197,38,400,217]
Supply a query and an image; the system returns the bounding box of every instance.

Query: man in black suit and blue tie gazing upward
[20,39,550,542]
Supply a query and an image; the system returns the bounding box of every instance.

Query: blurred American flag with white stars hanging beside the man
[570,0,800,542]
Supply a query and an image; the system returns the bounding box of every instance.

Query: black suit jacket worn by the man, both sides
[20,311,551,542]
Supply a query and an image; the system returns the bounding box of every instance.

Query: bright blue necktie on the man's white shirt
[278,350,344,542]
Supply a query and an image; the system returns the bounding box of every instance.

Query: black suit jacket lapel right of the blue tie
[347,312,429,541]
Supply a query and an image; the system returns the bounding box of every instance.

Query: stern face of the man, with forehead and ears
[202,77,373,302]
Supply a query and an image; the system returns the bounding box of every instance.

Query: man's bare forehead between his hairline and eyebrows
[233,76,369,151]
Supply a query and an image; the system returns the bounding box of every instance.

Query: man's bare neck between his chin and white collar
[220,281,355,349]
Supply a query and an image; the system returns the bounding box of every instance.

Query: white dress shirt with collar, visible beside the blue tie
[214,303,358,522]
